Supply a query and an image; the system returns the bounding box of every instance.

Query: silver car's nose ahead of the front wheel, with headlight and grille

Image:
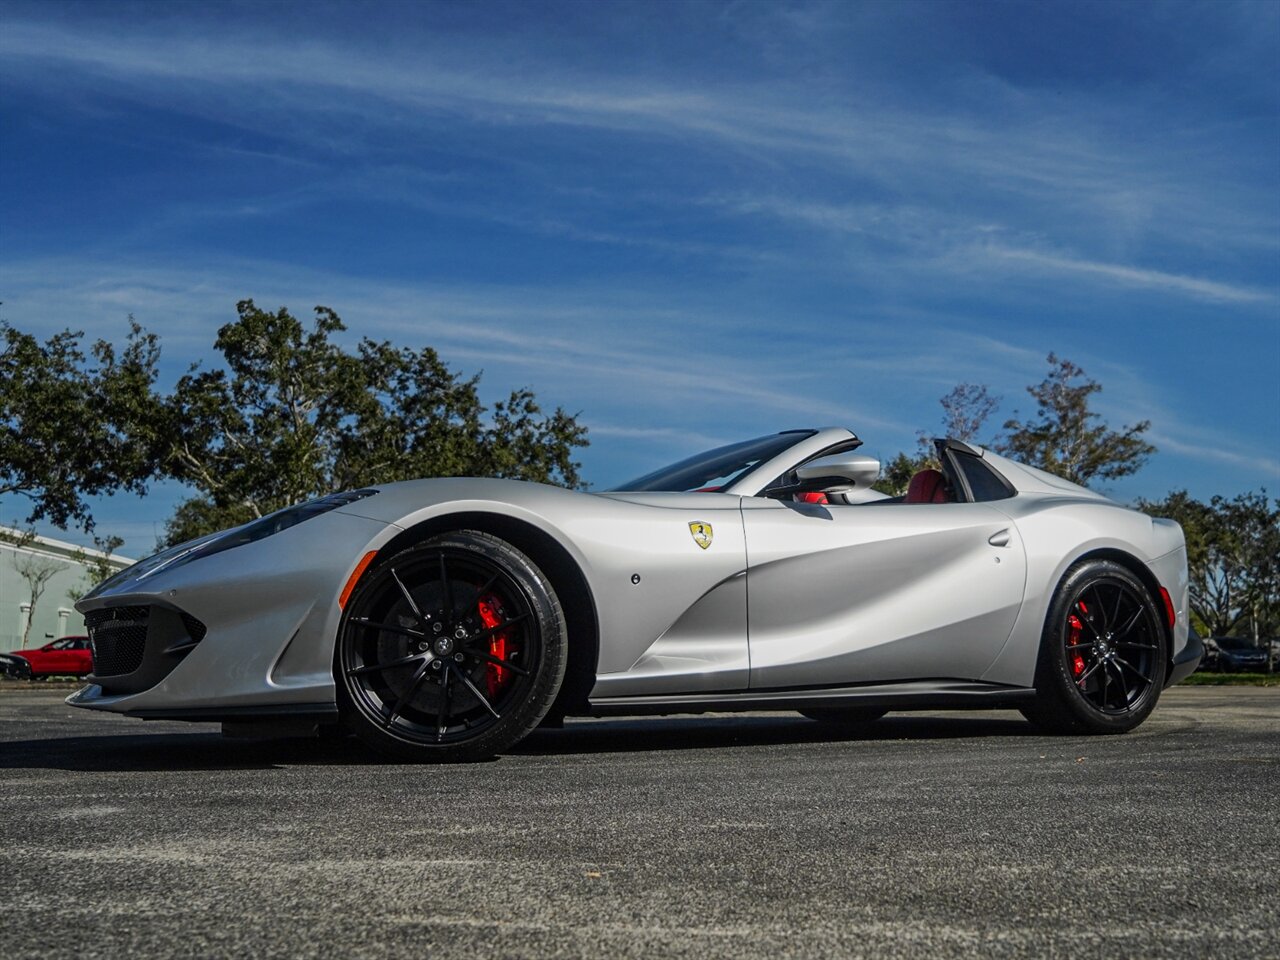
[67,511,399,719]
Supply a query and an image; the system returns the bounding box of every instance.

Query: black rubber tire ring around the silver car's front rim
[334,530,568,763]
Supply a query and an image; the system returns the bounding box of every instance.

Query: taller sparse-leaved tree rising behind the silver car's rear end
[998,353,1156,486]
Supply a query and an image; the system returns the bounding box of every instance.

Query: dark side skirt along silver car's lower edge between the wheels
[590,680,1036,717]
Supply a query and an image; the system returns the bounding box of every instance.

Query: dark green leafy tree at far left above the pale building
[0,317,160,530]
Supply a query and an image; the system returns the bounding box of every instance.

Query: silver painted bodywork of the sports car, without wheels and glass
[68,428,1188,716]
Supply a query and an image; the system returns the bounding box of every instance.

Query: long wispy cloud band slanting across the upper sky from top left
[0,20,1259,244]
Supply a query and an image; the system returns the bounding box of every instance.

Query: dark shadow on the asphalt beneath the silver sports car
[0,713,1038,772]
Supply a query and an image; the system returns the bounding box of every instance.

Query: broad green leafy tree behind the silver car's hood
[163,301,586,543]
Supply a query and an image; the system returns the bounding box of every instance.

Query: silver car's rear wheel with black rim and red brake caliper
[1021,559,1169,733]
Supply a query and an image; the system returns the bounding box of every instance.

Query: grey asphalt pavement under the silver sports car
[0,687,1280,960]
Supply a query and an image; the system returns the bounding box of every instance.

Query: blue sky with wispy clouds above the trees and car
[0,3,1280,554]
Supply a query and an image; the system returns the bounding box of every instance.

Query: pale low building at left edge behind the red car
[0,527,133,653]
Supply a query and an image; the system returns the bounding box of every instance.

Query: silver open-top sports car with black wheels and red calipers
[68,428,1202,760]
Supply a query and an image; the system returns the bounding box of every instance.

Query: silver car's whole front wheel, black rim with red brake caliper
[334,530,568,762]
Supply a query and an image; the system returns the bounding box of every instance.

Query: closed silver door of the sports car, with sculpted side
[742,497,1027,689]
